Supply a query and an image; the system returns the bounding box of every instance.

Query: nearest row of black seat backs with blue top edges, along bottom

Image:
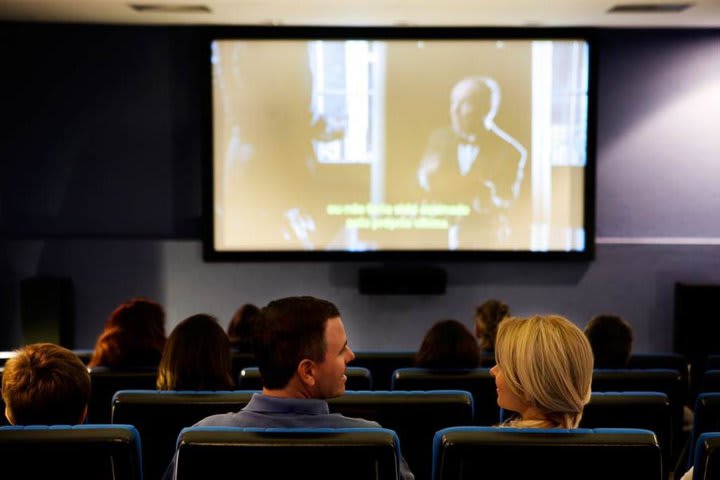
[0,425,680,480]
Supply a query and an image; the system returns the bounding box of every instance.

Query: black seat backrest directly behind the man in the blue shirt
[175,427,399,480]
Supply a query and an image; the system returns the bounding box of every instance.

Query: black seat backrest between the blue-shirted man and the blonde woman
[328,390,473,480]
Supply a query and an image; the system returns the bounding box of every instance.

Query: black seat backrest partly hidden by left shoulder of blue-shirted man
[112,390,253,478]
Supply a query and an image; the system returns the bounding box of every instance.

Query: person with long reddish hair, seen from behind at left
[88,298,166,370]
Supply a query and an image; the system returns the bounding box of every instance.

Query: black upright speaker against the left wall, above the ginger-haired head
[20,277,75,348]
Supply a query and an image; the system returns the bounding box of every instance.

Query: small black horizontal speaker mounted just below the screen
[358,266,447,295]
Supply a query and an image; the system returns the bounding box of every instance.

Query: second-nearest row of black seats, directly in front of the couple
[112,390,673,479]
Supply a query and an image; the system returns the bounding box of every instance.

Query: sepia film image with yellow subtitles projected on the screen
[212,39,588,252]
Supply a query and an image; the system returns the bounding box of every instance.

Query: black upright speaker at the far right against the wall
[673,283,720,362]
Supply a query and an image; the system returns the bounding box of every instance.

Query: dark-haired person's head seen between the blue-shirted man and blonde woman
[415,320,480,368]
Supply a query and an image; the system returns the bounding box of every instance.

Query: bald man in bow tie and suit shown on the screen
[417,76,527,250]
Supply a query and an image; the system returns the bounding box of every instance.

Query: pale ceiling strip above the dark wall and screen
[0,0,720,28]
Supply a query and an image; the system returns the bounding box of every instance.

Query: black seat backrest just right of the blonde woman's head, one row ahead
[580,392,675,477]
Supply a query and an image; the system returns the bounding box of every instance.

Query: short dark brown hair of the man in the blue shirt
[255,297,340,390]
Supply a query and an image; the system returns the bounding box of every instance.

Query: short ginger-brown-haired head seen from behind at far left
[2,343,90,425]
